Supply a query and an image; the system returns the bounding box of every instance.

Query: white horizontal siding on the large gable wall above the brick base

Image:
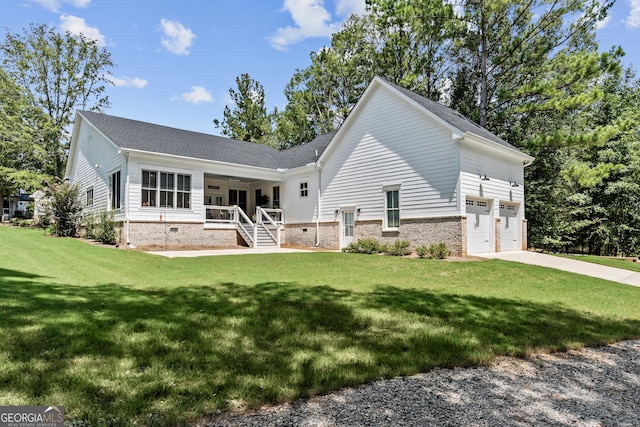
[321,87,459,222]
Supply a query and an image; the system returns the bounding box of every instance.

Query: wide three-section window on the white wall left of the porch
[142,170,191,209]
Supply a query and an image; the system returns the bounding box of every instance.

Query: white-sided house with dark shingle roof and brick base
[66,78,533,255]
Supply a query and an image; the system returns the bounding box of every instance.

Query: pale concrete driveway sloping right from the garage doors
[473,251,640,286]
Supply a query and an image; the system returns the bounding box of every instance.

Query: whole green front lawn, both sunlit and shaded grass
[0,227,640,426]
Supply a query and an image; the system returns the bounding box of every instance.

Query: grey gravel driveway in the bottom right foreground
[198,340,640,427]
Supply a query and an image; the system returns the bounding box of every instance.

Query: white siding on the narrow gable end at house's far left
[68,120,126,215]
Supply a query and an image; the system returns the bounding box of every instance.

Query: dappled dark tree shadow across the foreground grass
[0,270,640,425]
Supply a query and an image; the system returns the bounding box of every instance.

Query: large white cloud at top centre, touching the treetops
[269,0,350,50]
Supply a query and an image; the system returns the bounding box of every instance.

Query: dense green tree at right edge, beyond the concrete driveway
[563,69,640,255]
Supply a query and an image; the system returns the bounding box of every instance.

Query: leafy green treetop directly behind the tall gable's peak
[276,0,459,146]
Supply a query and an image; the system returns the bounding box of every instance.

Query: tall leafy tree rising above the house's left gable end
[0,24,114,176]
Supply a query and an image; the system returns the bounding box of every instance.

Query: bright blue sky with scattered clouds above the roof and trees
[0,0,640,134]
